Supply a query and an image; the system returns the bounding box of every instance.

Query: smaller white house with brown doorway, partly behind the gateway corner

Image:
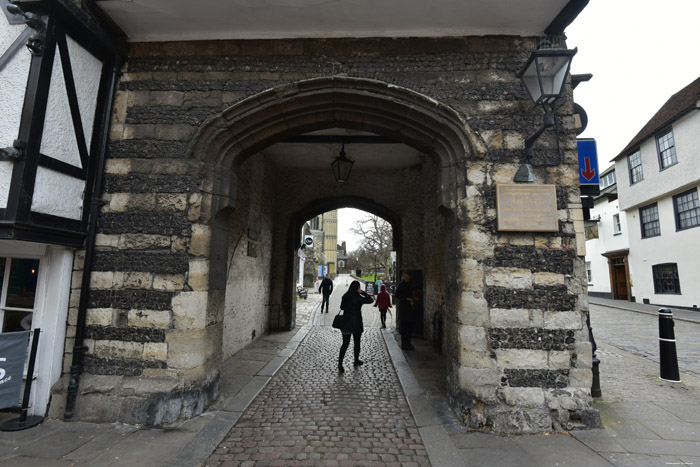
[586,166,629,300]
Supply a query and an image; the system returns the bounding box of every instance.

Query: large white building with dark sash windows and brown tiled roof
[614,78,700,307]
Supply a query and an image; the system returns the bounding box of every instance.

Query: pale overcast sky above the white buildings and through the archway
[338,0,700,251]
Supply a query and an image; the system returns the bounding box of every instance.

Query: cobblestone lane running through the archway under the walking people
[205,278,430,467]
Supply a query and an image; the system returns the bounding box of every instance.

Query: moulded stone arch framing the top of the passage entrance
[187,77,486,213]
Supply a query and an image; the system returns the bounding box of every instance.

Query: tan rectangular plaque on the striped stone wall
[496,184,559,232]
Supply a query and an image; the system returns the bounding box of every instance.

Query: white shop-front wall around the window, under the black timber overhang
[0,240,73,416]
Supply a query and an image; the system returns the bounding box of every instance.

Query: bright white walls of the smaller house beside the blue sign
[586,198,629,293]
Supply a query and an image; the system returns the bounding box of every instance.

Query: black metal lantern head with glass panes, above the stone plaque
[517,45,578,105]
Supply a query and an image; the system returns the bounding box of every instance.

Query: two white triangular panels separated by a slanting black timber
[41,37,102,167]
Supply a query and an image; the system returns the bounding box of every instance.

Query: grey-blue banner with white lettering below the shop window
[0,331,29,409]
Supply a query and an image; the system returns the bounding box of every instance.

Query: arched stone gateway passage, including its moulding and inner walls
[190,77,478,380]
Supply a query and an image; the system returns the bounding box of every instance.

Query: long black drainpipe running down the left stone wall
[63,56,123,420]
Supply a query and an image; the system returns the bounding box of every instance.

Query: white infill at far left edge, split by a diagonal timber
[0,19,31,148]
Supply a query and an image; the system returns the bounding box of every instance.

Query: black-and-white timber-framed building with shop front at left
[0,0,114,415]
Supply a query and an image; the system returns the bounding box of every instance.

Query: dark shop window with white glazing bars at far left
[0,258,39,332]
